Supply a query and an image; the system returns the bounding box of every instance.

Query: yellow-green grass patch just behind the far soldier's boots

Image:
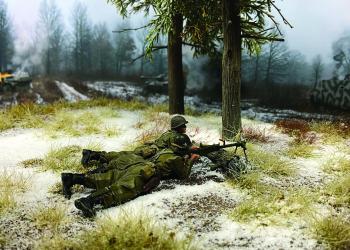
[41,144,100,173]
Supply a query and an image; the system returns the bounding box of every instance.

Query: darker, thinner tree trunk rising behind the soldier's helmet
[168,14,185,114]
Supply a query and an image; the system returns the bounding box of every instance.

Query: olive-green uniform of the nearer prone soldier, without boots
[85,149,192,207]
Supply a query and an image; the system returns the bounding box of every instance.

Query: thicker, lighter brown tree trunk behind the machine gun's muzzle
[222,0,242,139]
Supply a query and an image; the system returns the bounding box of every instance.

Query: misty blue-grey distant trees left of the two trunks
[0,0,166,78]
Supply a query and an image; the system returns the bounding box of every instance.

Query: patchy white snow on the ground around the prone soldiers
[0,108,348,249]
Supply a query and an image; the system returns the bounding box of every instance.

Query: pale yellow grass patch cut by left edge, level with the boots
[0,170,30,215]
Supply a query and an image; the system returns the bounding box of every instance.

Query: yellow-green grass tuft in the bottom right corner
[311,215,350,250]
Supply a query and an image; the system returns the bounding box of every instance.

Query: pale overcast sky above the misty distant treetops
[5,0,350,60]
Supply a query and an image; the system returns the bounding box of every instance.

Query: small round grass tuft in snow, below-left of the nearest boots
[31,205,68,231]
